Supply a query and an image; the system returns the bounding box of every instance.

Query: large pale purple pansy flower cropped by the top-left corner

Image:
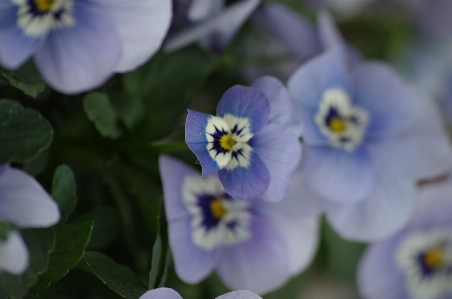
[0,0,171,93]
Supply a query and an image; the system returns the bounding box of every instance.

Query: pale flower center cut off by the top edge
[11,0,75,37]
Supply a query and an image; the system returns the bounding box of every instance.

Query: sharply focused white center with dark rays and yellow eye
[205,114,253,170]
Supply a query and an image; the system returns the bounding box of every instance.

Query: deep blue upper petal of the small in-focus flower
[217,85,270,134]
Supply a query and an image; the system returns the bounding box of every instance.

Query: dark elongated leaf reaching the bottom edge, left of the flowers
[77,251,147,299]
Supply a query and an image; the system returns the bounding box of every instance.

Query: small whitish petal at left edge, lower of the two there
[0,231,29,275]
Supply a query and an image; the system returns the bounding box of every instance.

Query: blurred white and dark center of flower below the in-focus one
[182,176,251,250]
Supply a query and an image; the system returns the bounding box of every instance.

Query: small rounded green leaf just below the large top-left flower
[83,92,122,139]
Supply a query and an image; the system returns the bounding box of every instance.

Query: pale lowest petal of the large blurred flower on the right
[326,172,416,242]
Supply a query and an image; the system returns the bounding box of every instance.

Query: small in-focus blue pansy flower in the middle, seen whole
[185,77,301,201]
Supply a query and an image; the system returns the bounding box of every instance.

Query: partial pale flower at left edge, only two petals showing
[0,165,60,274]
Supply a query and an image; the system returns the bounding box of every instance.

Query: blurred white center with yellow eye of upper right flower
[315,88,369,152]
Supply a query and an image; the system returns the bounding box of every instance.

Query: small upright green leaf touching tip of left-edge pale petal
[52,165,77,222]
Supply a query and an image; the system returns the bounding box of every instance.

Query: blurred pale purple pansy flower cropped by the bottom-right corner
[358,179,452,299]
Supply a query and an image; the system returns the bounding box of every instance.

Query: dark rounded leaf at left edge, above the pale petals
[0,100,53,164]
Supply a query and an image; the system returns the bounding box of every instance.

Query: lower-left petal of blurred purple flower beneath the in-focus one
[168,218,221,283]
